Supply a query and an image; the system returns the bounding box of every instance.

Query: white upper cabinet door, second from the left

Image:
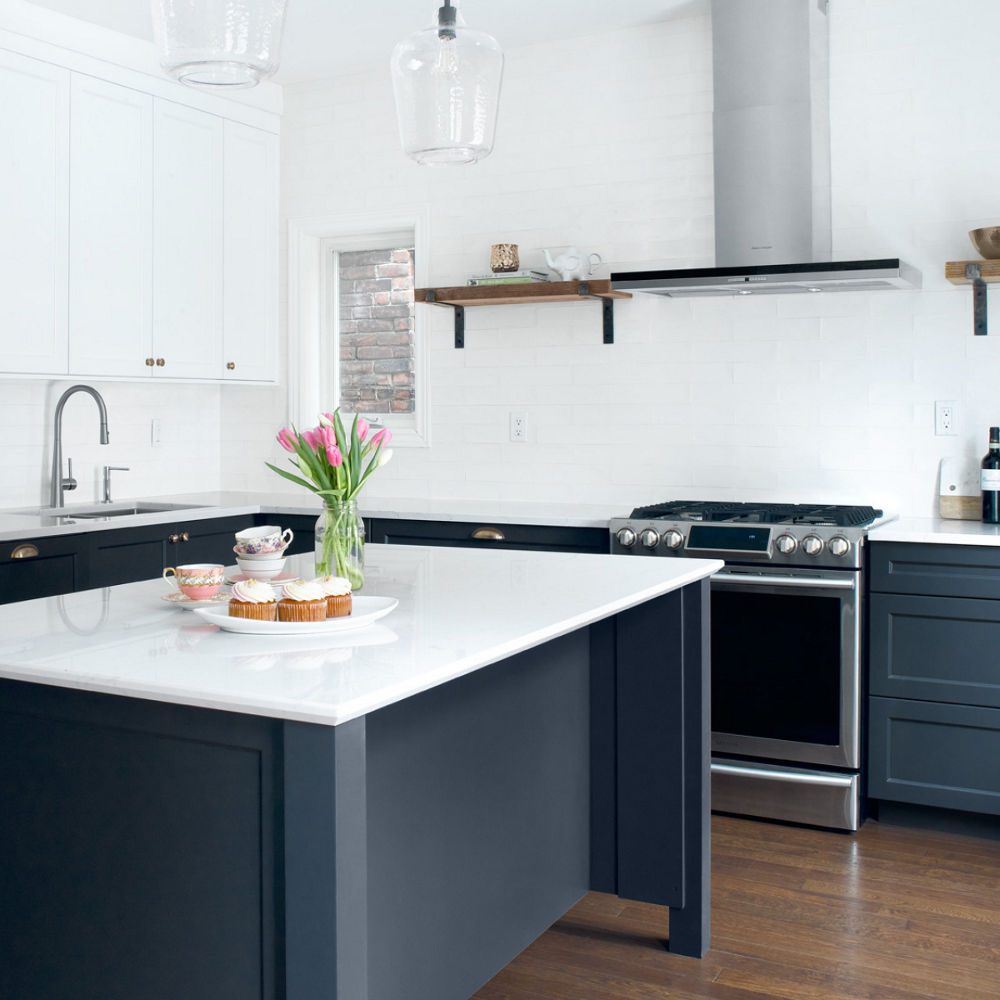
[69,74,153,376]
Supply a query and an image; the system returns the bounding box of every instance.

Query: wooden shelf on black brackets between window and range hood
[413,278,632,347]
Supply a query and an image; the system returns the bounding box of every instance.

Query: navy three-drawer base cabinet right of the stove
[868,542,1000,815]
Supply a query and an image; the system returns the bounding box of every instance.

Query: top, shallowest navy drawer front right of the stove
[869,542,1000,600]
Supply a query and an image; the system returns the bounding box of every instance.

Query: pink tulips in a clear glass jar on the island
[265,407,392,590]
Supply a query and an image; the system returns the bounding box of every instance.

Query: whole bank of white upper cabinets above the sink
[0,27,278,382]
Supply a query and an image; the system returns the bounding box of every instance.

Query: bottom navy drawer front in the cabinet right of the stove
[868,698,1000,815]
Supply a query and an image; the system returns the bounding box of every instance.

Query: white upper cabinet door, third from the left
[153,100,223,379]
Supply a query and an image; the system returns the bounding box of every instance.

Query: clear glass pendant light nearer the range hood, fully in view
[392,0,503,166]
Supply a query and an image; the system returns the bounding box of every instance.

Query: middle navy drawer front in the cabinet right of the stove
[869,594,1000,708]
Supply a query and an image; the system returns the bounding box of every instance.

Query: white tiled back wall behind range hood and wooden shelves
[240,0,1000,515]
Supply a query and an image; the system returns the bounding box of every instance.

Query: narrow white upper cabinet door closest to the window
[223,122,278,381]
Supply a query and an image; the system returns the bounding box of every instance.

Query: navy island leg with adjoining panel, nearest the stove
[617,581,711,958]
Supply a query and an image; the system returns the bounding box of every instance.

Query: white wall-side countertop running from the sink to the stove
[0,490,616,541]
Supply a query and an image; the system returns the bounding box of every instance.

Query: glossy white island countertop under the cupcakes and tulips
[0,545,723,725]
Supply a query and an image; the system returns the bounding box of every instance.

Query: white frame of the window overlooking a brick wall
[288,213,430,447]
